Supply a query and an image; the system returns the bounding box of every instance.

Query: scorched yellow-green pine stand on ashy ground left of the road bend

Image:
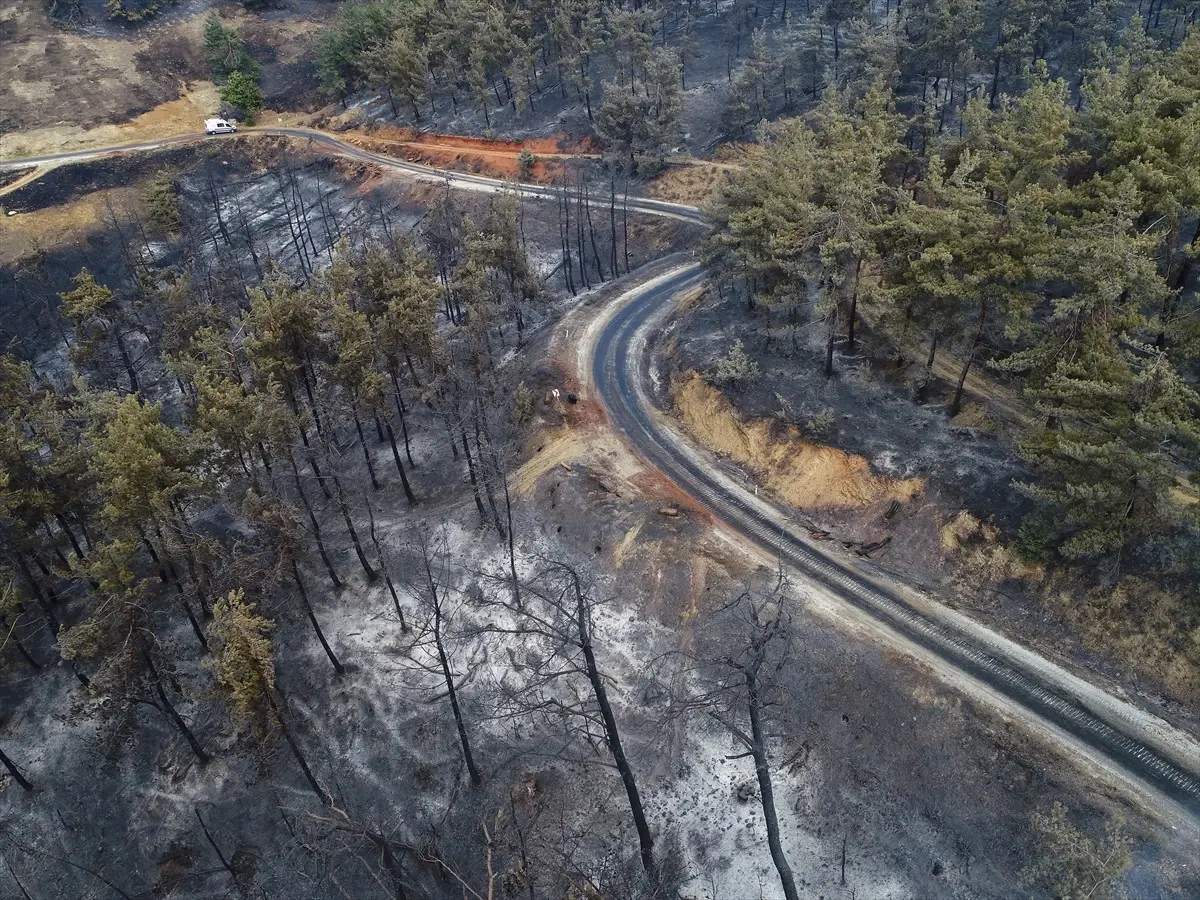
[0,190,544,760]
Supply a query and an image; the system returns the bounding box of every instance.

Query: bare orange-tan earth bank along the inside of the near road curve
[674,374,924,509]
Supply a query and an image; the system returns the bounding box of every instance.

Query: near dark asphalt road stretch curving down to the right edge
[592,265,1200,816]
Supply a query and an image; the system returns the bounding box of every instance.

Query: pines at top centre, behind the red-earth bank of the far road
[317,0,682,155]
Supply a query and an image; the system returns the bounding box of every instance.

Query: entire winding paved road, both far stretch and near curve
[0,127,1200,816]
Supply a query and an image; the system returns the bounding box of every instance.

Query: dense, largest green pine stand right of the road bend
[707,30,1200,574]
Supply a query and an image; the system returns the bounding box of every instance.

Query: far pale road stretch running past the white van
[0,126,708,226]
